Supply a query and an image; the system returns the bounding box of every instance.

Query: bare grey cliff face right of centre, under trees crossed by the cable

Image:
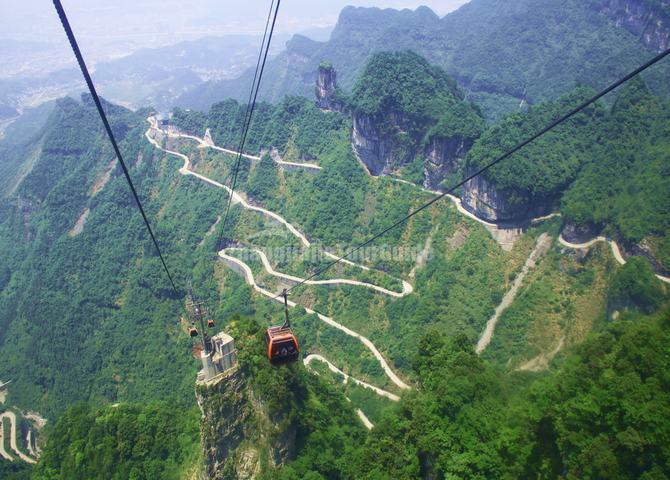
[461,175,556,224]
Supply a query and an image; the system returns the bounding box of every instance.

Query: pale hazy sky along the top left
[0,0,468,46]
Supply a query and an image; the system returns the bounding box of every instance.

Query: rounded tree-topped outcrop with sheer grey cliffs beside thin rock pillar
[345,52,484,188]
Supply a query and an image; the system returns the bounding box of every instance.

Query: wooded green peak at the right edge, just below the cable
[562,80,670,260]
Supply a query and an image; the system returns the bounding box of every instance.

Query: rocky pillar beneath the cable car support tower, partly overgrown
[196,368,297,480]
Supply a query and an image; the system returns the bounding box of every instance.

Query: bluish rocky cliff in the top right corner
[594,0,670,52]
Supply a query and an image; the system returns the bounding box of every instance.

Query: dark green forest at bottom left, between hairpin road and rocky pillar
[31,403,200,480]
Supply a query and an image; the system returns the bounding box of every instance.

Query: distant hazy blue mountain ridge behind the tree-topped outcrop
[180,0,669,119]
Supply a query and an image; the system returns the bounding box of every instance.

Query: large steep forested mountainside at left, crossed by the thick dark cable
[0,96,222,418]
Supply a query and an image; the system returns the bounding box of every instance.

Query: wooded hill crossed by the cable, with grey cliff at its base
[463,89,605,222]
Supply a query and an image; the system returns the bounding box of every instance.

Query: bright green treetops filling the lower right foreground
[280,309,670,479]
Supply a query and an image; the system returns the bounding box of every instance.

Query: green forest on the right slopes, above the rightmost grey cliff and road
[466,78,670,269]
